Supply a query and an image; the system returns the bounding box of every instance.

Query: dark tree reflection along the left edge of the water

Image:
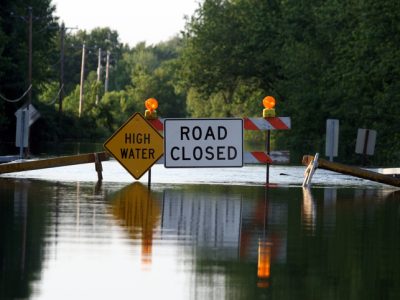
[0,180,46,299]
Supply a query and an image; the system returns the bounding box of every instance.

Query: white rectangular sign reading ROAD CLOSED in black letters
[164,119,243,168]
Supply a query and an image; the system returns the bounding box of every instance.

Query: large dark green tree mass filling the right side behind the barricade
[182,0,400,164]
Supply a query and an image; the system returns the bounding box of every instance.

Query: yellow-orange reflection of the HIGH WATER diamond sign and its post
[112,182,160,265]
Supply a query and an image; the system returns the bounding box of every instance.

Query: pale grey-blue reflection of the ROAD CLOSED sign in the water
[161,189,242,255]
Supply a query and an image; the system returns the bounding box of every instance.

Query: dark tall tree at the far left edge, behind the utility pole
[0,0,58,141]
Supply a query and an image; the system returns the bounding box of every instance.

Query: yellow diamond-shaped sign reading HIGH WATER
[104,113,164,179]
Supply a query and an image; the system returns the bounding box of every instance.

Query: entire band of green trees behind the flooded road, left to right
[0,0,400,165]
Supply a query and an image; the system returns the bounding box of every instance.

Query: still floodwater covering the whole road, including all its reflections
[0,161,400,300]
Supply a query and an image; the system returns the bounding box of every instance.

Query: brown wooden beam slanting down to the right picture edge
[302,155,400,187]
